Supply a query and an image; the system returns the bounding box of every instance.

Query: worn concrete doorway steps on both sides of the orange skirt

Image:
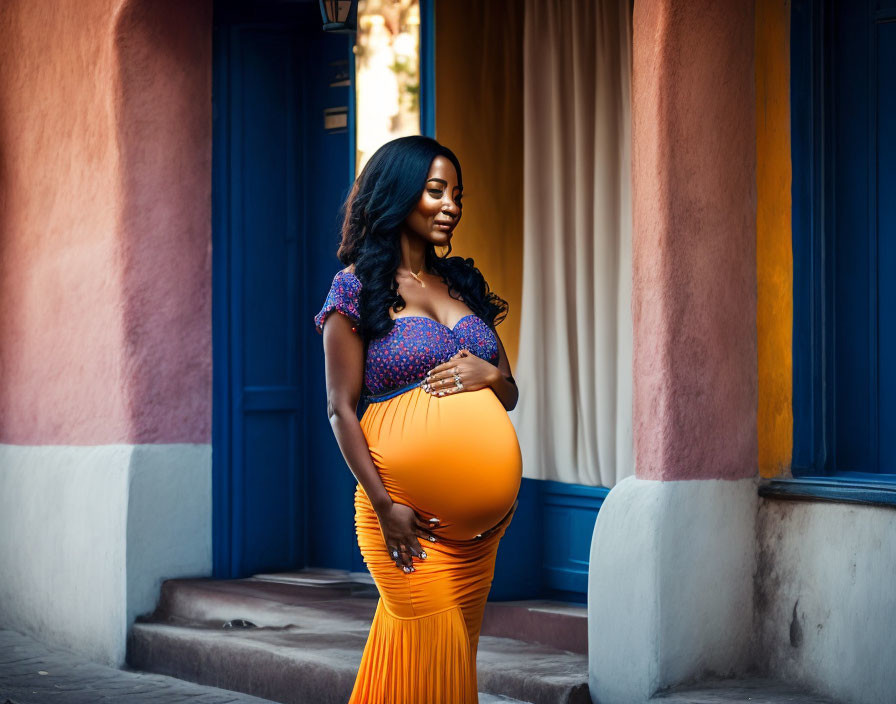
[127,570,590,704]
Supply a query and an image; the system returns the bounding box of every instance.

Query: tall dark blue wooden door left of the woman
[212,2,357,577]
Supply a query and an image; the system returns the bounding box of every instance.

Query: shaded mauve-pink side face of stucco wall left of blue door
[114,0,212,443]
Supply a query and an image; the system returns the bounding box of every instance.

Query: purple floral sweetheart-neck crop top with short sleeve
[314,269,498,401]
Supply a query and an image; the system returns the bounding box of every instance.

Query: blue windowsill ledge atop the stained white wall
[759,473,896,508]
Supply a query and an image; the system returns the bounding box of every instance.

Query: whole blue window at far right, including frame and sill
[792,0,896,496]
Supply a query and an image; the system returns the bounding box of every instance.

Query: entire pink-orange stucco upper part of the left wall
[0,0,211,445]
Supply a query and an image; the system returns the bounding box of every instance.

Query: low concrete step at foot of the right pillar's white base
[650,679,837,704]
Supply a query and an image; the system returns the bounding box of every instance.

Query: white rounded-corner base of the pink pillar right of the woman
[588,477,758,704]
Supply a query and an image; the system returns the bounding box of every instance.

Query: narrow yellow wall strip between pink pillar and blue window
[756,0,793,477]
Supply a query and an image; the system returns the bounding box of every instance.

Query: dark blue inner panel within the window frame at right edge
[825,0,896,474]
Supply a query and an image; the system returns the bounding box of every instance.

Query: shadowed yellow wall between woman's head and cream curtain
[435,0,523,368]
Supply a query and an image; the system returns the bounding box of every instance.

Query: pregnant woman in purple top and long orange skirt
[314,136,522,704]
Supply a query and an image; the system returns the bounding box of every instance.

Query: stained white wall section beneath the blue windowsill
[756,499,896,704]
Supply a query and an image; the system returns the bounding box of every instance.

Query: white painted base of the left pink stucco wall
[0,444,212,667]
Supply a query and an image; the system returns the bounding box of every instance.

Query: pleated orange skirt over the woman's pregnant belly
[349,387,522,704]
